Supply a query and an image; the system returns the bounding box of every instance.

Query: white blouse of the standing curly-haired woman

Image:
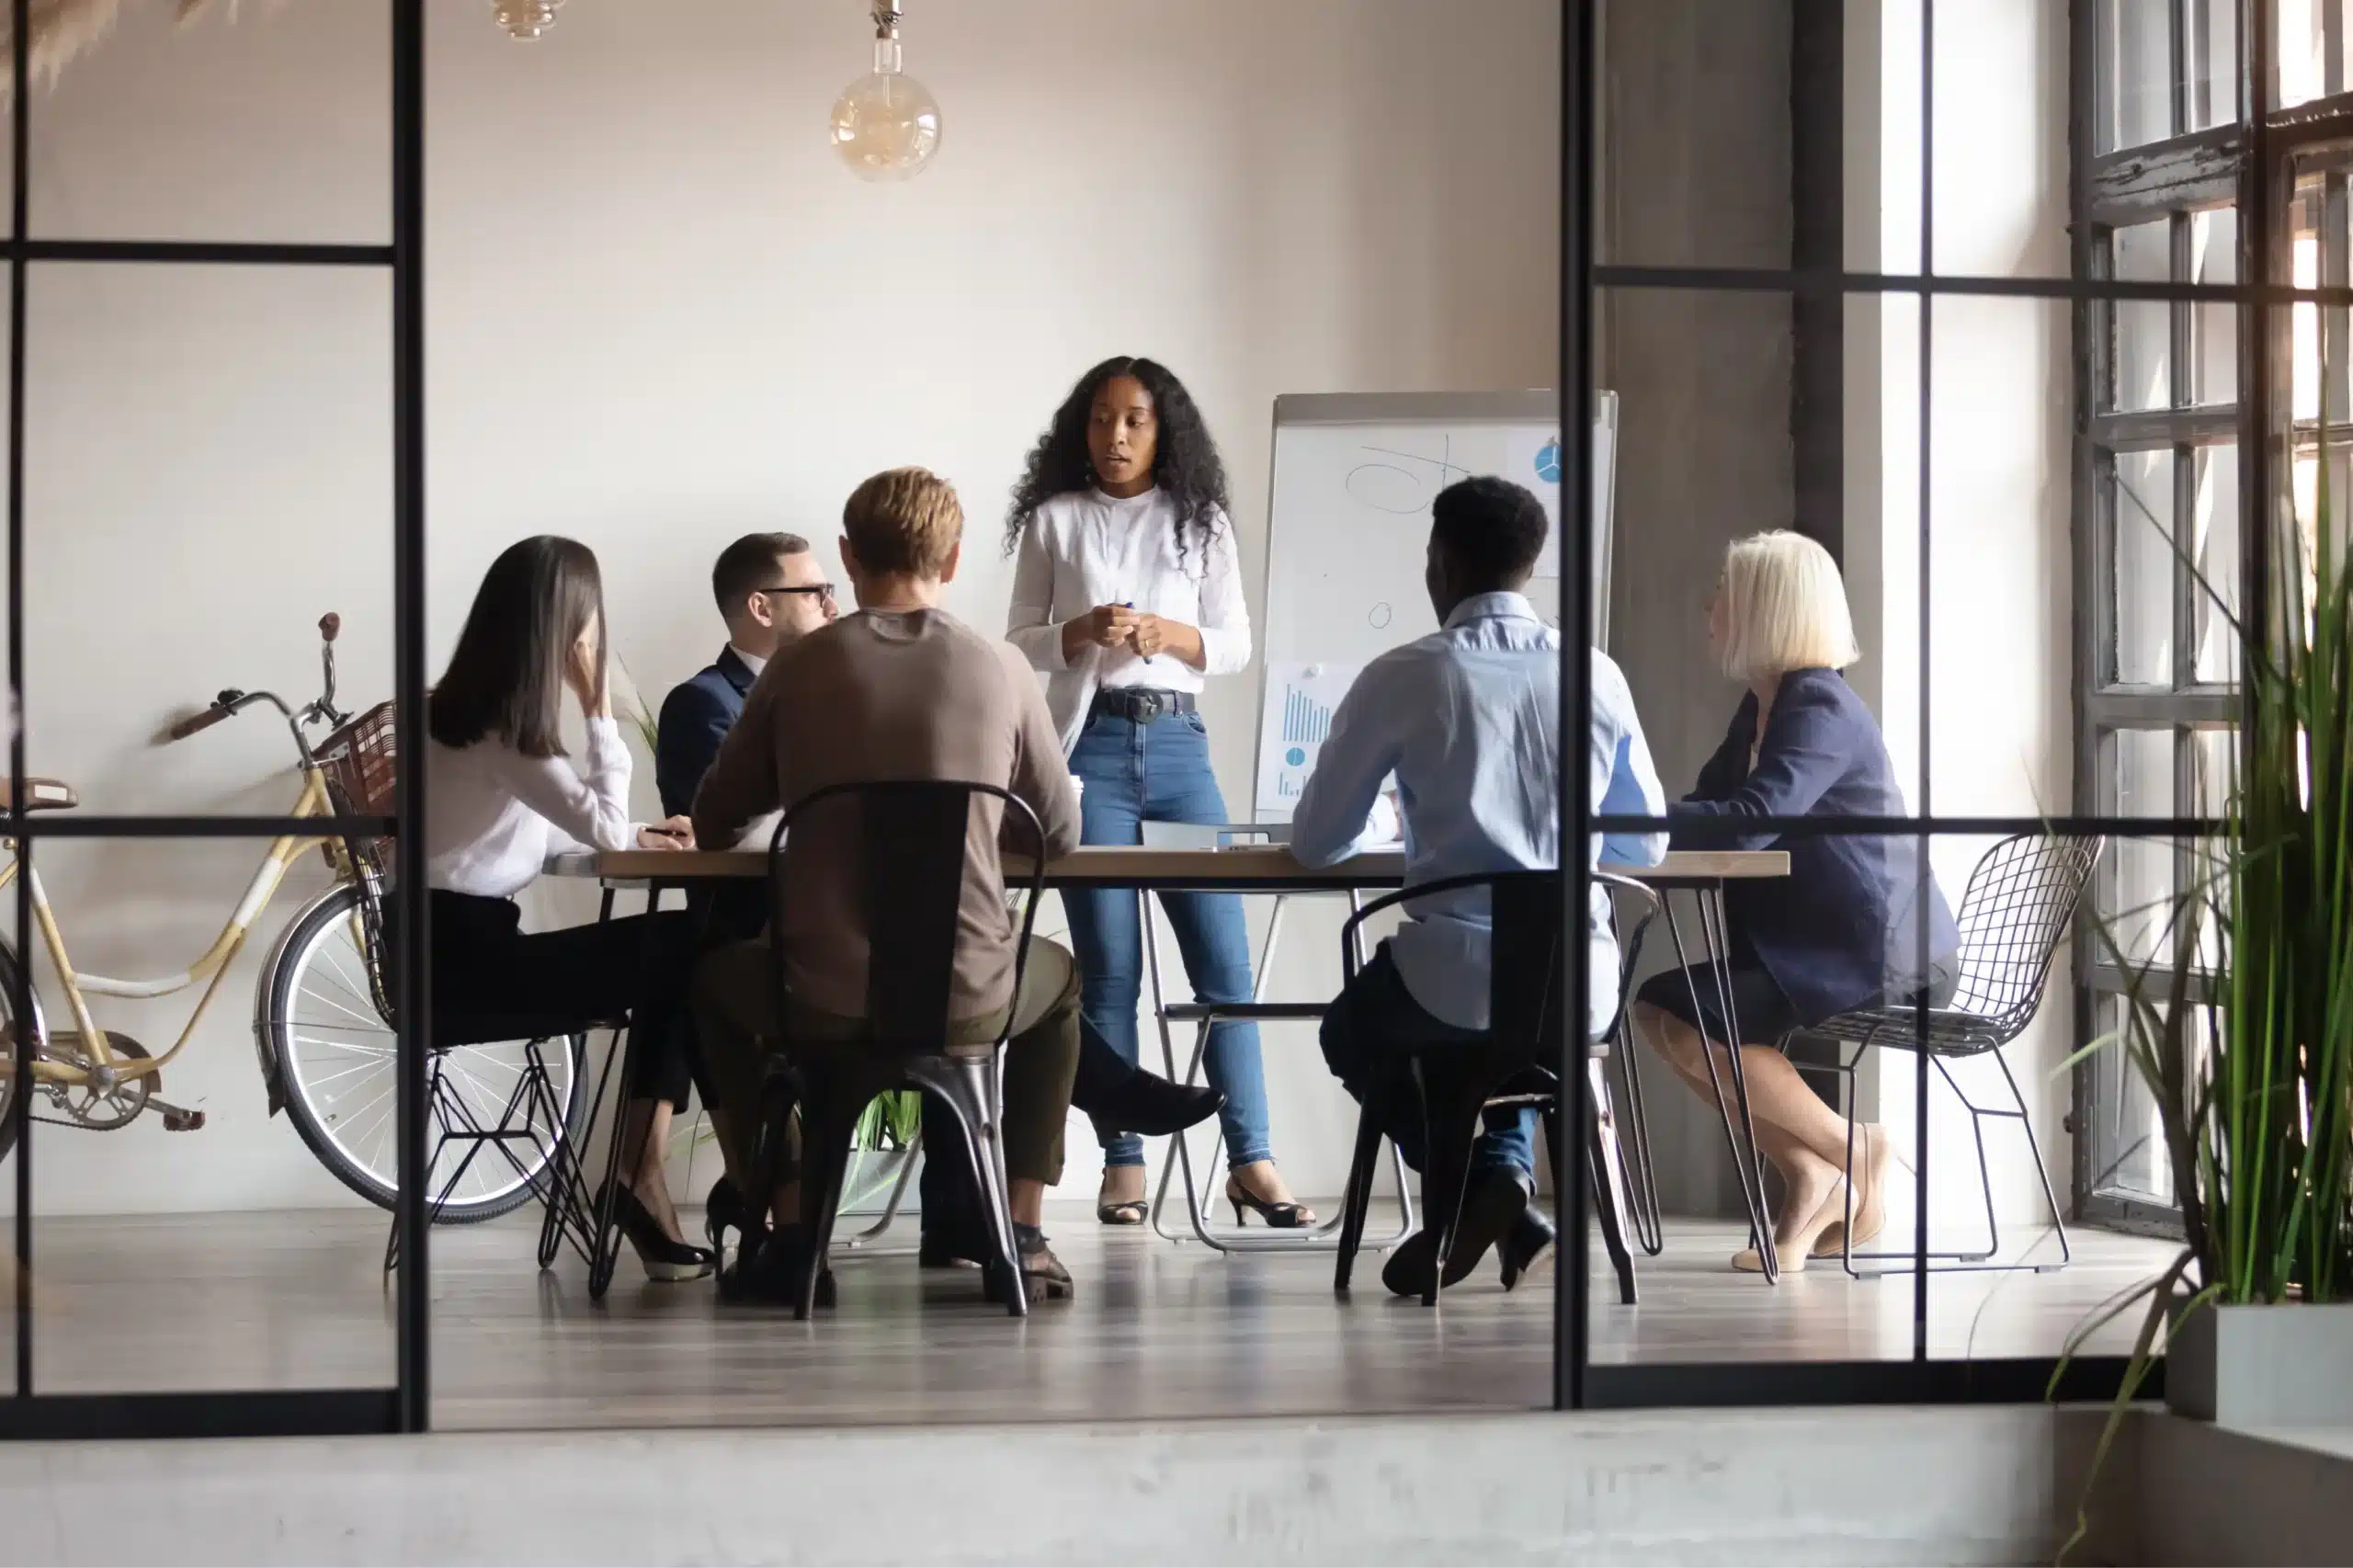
[1005,487,1249,754]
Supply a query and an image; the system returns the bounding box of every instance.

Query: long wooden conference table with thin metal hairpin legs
[546,843,1789,1280]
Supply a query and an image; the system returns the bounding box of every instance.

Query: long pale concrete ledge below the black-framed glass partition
[0,1408,2136,1568]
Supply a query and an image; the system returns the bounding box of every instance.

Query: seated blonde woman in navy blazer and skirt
[1633,532,1960,1271]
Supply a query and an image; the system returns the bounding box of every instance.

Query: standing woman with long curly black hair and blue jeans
[1005,358,1315,1229]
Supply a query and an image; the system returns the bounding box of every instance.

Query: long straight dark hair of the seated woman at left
[426,534,605,756]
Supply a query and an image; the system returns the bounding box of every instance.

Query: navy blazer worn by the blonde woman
[1668,668,1960,1024]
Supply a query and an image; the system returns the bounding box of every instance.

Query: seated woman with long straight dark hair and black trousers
[426,534,710,1280]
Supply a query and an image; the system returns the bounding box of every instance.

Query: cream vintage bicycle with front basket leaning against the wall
[0,615,588,1224]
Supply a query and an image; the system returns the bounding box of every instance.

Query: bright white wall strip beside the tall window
[1847,0,2073,1245]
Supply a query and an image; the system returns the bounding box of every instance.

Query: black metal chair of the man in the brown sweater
[760,779,1045,1318]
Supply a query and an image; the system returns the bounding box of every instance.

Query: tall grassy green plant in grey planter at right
[2062,494,2353,1556]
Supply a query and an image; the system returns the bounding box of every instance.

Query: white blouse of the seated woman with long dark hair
[426,718,638,900]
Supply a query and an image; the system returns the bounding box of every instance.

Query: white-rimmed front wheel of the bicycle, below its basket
[256,883,588,1224]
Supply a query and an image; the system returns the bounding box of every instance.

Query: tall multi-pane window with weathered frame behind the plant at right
[2073,0,2353,1221]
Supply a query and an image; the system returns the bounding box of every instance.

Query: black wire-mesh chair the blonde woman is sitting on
[1783,834,2106,1278]
